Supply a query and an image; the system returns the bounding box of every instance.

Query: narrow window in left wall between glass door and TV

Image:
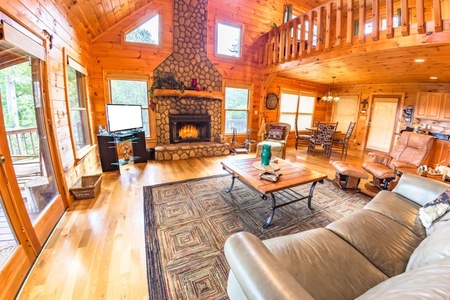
[67,57,91,158]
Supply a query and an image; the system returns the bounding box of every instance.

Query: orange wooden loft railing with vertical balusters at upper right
[262,0,450,67]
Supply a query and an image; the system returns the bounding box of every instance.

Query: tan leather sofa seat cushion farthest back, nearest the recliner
[364,191,426,239]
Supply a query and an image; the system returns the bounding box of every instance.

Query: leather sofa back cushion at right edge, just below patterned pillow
[406,217,450,271]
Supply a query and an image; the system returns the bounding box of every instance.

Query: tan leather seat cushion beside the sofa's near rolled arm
[263,228,387,299]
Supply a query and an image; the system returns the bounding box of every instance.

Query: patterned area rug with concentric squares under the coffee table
[144,175,371,299]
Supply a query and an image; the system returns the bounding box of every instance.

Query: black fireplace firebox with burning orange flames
[169,114,211,144]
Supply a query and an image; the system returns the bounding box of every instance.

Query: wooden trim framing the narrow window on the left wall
[63,48,95,164]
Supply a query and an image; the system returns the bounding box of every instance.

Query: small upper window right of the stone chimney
[216,23,242,57]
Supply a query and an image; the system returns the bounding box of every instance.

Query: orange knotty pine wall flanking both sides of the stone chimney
[92,0,292,147]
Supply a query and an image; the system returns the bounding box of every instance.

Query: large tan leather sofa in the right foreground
[224,174,450,300]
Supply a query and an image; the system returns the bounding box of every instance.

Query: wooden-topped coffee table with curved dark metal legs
[221,158,327,228]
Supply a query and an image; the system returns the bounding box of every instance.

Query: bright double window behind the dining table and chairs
[280,92,315,130]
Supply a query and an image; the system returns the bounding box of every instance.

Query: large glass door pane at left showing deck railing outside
[0,59,59,223]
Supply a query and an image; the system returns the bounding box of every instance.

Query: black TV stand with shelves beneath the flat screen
[97,130,147,172]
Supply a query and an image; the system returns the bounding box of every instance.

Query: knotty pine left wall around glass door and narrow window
[0,0,98,202]
